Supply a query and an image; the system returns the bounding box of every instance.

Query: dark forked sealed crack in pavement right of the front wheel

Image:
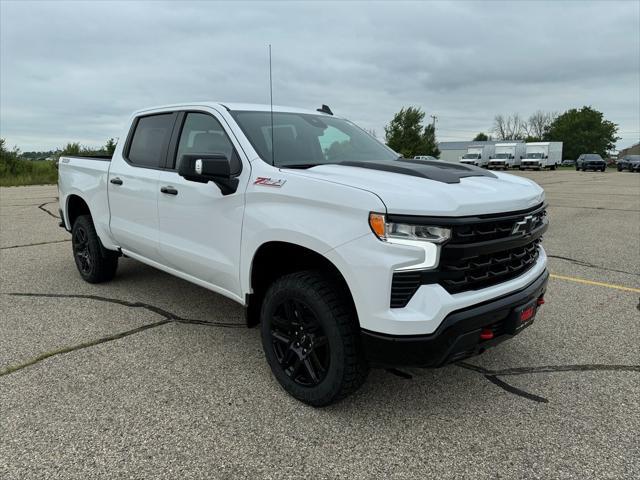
[456,362,640,403]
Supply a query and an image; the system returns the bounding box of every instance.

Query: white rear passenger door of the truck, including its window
[108,112,177,261]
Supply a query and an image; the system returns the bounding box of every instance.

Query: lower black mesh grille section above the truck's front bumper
[439,240,539,293]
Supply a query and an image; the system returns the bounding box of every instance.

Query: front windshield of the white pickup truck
[230,111,398,167]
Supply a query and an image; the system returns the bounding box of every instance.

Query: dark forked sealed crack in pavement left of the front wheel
[0,292,246,377]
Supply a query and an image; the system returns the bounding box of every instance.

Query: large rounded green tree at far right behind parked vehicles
[544,106,620,159]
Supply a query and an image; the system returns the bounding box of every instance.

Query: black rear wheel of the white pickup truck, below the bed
[71,215,118,283]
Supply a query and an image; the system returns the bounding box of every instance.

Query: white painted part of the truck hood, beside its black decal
[296,165,544,216]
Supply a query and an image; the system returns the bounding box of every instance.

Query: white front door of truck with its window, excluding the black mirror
[158,111,250,296]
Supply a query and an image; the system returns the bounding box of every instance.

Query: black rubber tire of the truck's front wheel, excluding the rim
[260,270,369,407]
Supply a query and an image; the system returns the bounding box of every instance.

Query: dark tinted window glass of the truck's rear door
[128,113,174,168]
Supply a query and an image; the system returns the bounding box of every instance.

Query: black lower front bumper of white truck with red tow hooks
[361,269,549,367]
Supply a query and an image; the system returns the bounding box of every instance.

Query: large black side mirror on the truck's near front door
[178,153,238,195]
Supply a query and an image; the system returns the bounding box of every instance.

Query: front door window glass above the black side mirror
[176,113,241,172]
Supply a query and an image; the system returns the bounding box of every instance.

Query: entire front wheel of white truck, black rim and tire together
[260,271,368,407]
